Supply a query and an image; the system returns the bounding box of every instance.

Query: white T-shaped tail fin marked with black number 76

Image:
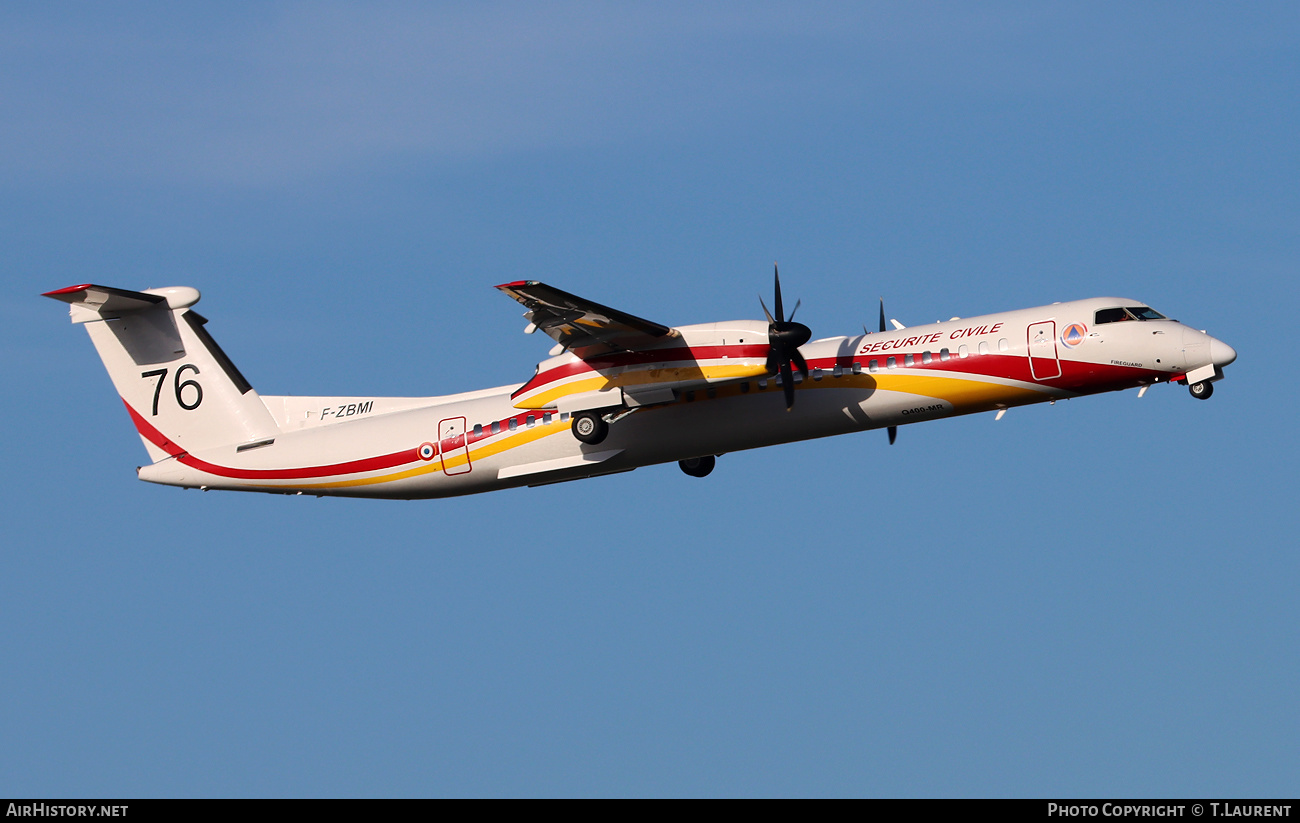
[44,285,280,463]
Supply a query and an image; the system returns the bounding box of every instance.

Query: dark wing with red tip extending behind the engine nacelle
[497,280,677,359]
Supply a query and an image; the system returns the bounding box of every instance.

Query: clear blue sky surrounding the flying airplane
[0,3,1300,797]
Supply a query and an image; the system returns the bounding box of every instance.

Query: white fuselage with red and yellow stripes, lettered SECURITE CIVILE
[127,298,1235,498]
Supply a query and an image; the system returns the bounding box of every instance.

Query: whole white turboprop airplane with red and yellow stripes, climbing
[44,270,1236,499]
